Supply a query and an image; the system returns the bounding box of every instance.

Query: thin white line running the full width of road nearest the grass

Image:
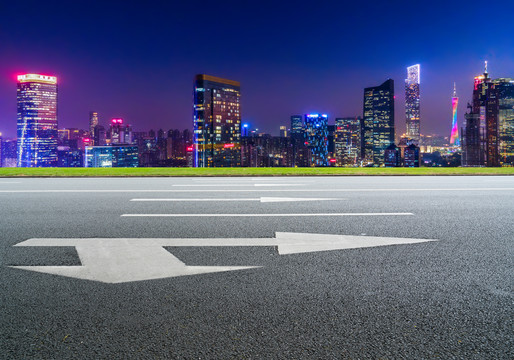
[0,187,514,194]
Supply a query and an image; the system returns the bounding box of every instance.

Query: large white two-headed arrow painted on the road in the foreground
[11,233,436,283]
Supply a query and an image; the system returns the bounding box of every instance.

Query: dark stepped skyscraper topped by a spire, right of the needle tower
[462,61,500,166]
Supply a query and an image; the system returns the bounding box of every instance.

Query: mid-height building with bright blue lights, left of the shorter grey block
[305,114,328,166]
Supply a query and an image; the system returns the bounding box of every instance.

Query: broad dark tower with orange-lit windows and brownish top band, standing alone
[193,74,241,167]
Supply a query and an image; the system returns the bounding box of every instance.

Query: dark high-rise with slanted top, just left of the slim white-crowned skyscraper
[362,79,394,166]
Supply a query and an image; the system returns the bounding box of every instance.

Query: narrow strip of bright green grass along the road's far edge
[0,167,514,177]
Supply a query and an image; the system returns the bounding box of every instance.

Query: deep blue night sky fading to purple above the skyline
[0,0,514,137]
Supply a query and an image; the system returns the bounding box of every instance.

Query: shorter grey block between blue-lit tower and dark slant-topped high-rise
[334,117,361,165]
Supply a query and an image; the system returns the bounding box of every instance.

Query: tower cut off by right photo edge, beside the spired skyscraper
[493,78,514,166]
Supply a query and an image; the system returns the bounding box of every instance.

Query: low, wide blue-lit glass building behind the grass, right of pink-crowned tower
[84,145,139,167]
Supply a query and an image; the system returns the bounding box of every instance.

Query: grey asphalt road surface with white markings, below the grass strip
[0,176,514,359]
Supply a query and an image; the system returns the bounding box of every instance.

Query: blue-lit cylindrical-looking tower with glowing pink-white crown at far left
[17,74,57,167]
